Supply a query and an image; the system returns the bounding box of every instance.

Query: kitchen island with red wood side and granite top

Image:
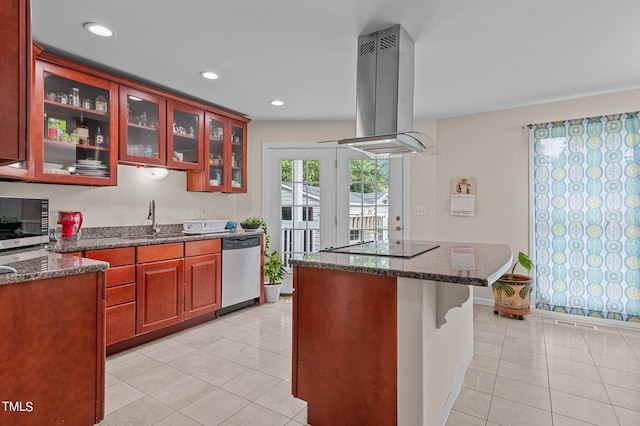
[291,241,512,426]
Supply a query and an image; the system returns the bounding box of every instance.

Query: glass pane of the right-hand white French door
[349,159,389,242]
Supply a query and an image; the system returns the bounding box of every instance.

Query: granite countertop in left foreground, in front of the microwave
[0,249,109,285]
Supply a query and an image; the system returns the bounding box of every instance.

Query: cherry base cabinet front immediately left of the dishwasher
[184,240,222,319]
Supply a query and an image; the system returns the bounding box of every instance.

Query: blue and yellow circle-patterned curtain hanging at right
[533,112,640,322]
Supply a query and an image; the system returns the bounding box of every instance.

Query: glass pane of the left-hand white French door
[280,159,320,268]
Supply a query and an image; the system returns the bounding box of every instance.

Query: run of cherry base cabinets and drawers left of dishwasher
[82,239,228,352]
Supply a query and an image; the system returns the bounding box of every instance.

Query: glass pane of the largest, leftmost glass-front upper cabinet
[43,73,111,177]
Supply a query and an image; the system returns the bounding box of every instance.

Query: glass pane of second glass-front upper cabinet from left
[127,96,160,158]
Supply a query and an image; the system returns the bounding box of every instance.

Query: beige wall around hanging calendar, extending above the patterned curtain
[434,90,640,299]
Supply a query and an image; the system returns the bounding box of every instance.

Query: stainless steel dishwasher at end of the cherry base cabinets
[217,235,261,315]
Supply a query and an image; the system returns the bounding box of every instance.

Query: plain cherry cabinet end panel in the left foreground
[0,272,105,426]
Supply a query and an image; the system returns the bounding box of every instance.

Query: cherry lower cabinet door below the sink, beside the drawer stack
[136,259,184,334]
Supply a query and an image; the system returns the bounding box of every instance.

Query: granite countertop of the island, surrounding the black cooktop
[290,240,513,286]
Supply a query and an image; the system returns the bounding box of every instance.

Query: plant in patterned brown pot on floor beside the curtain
[491,252,533,320]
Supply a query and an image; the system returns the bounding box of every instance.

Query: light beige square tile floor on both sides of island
[100,297,640,426]
